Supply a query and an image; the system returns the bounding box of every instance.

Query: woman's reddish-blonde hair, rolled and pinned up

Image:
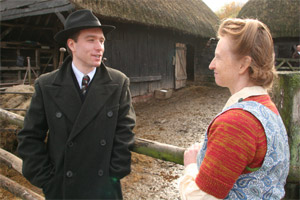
[218,18,276,88]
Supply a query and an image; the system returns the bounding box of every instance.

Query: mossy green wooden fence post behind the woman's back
[272,72,300,198]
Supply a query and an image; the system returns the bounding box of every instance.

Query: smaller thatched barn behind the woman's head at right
[238,0,300,58]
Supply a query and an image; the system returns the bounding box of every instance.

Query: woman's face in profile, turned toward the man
[209,36,244,94]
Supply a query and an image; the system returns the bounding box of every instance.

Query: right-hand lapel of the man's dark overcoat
[68,65,118,141]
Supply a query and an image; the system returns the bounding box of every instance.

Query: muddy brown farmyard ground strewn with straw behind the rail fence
[0,83,230,200]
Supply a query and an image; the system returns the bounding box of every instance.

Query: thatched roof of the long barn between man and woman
[71,0,219,38]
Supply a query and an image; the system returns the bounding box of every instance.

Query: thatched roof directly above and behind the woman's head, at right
[238,0,300,38]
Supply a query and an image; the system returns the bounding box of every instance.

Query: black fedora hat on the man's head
[54,9,116,44]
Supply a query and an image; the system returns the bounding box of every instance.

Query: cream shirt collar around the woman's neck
[223,86,268,110]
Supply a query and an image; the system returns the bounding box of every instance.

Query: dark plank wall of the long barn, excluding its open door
[102,21,210,96]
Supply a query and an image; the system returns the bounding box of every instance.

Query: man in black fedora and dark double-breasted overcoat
[18,10,135,199]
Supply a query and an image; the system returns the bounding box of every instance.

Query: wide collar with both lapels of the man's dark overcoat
[49,57,118,140]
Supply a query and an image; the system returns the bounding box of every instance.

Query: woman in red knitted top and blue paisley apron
[179,19,289,199]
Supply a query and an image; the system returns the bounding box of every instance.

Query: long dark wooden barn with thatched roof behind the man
[1,0,218,96]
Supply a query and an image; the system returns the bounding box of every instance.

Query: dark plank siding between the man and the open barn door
[104,23,183,96]
